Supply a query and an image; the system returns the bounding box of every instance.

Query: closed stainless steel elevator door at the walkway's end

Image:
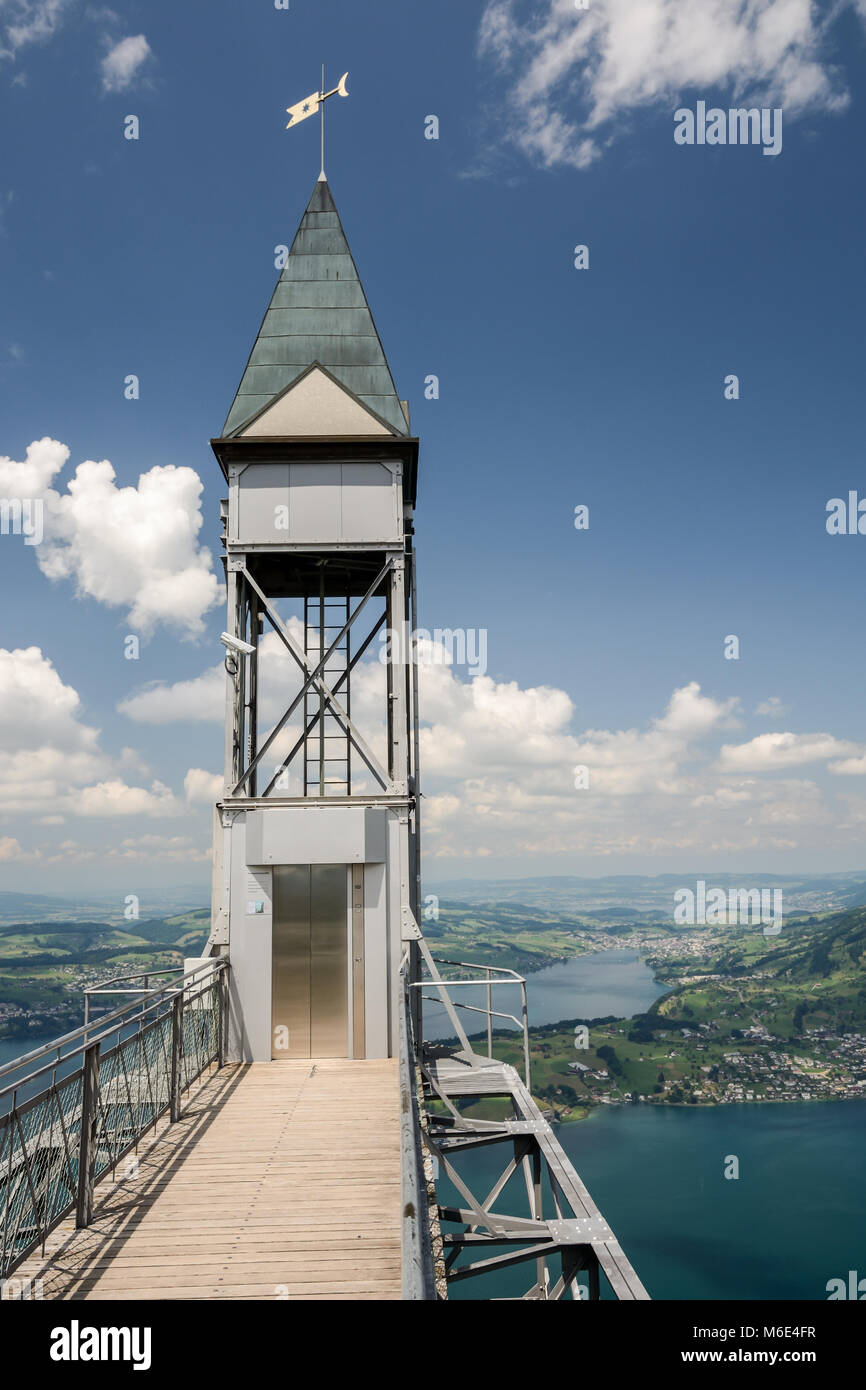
[271,865,349,1061]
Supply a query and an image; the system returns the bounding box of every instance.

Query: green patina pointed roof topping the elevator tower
[222,179,409,436]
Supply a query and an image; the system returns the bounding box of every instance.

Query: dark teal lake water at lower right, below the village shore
[446,1101,866,1300]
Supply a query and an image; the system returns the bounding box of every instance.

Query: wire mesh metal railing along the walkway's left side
[0,956,228,1280]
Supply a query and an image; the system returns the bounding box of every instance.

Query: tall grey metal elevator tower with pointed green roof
[210,177,420,1062]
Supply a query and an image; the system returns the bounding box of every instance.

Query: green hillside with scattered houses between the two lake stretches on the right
[461,908,866,1119]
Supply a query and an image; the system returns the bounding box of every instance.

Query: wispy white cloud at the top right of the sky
[478,0,865,168]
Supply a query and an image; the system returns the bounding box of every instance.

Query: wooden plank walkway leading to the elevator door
[15,1059,402,1300]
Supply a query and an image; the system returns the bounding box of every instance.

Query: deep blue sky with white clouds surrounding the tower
[0,0,866,892]
